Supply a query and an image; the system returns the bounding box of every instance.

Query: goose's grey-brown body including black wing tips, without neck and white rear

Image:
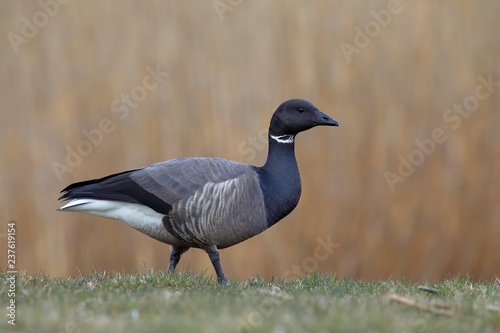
[61,158,274,248]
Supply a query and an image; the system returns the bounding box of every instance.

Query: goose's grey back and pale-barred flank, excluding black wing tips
[131,158,267,248]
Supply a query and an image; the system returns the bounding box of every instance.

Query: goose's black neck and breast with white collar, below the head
[257,135,301,226]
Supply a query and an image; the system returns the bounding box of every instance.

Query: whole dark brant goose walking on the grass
[58,99,338,283]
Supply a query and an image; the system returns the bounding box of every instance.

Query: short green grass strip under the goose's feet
[0,271,500,333]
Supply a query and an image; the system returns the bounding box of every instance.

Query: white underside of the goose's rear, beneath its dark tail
[58,199,164,238]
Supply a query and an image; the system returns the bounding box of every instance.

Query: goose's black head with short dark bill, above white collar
[269,99,339,136]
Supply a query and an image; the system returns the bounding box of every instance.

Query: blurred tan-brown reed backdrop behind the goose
[0,0,500,280]
